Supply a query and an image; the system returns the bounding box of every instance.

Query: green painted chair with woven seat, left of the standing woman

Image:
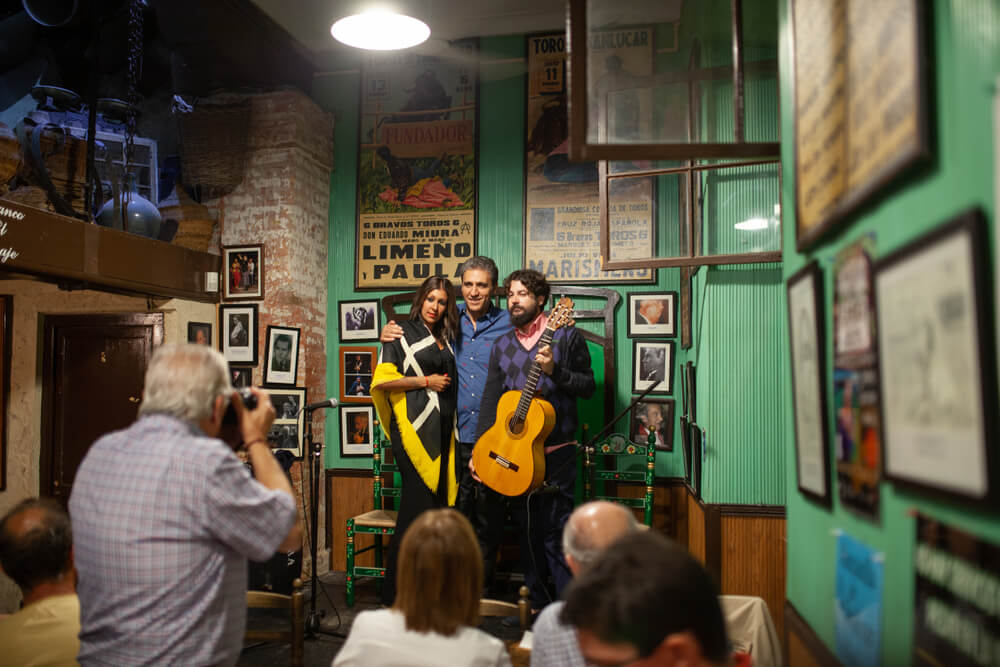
[347,421,400,607]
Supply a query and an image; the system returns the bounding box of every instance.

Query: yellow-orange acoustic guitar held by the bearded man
[472,297,573,496]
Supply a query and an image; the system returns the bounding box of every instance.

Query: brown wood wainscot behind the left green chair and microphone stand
[326,468,375,572]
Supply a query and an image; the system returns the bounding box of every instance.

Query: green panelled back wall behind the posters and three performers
[313,24,787,504]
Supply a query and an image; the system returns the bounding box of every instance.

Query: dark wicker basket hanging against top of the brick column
[180,100,250,198]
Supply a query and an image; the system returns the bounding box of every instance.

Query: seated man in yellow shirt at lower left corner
[0,498,80,667]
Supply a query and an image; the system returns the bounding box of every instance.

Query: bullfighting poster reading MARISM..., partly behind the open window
[524,28,656,284]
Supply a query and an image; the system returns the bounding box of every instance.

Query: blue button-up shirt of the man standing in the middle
[455,302,514,443]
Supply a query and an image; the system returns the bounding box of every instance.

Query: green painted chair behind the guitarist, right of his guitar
[583,424,656,526]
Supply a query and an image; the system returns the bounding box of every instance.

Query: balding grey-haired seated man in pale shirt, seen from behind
[531,500,636,667]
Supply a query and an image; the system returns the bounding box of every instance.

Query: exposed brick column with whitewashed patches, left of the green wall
[213,90,333,573]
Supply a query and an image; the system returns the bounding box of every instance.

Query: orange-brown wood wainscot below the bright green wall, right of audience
[720,515,785,636]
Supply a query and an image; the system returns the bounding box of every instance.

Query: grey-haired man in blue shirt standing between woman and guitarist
[381,256,512,585]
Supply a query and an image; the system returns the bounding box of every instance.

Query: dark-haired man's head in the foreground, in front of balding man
[560,531,730,667]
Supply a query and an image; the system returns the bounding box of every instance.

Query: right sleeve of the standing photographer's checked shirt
[203,452,297,562]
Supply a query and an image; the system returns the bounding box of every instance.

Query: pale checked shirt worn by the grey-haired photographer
[69,415,296,665]
